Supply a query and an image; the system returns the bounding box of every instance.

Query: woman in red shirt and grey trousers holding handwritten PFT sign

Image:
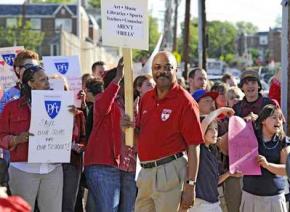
[0,65,63,212]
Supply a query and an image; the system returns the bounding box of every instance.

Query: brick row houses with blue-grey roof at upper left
[0,4,100,56]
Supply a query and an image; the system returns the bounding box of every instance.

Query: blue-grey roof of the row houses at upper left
[0,4,77,16]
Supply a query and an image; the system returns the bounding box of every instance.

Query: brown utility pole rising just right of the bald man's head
[183,0,190,79]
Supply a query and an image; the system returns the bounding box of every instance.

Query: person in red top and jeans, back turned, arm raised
[84,60,137,212]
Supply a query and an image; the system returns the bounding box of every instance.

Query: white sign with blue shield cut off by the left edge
[0,46,24,90]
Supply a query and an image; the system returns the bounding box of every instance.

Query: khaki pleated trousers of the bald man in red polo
[135,157,187,212]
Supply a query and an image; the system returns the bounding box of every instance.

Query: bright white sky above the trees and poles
[0,0,282,31]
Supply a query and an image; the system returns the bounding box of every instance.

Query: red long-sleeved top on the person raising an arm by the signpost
[84,82,121,167]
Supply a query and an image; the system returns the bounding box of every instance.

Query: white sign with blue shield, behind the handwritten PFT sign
[43,56,82,107]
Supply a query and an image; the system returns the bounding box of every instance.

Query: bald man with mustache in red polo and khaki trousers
[122,52,203,212]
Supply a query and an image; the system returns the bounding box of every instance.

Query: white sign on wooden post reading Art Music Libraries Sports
[101,0,149,50]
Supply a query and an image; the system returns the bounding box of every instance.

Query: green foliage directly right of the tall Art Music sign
[133,16,160,61]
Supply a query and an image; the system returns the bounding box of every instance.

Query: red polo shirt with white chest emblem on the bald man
[136,84,203,161]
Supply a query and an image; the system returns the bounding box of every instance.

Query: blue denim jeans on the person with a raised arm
[85,165,137,212]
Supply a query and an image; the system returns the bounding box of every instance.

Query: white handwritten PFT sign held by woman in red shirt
[28,90,73,163]
